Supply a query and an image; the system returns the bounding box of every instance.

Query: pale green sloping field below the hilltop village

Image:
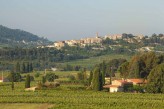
[58,54,131,68]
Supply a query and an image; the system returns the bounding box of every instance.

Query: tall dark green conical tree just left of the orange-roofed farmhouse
[92,67,103,91]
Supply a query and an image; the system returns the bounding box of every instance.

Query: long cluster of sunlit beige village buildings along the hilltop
[44,34,144,49]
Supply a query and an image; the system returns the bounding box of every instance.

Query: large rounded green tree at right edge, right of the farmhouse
[146,63,164,93]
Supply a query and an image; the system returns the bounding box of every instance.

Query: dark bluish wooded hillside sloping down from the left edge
[0,25,50,47]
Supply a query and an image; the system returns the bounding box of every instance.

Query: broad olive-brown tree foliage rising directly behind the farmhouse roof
[118,52,164,78]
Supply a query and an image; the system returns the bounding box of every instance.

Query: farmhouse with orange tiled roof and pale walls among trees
[103,80,133,92]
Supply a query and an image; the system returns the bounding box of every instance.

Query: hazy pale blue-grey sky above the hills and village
[0,0,164,41]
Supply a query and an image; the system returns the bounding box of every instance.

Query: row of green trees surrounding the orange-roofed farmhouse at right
[89,52,164,93]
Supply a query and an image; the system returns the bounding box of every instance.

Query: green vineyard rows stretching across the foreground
[0,82,164,109]
